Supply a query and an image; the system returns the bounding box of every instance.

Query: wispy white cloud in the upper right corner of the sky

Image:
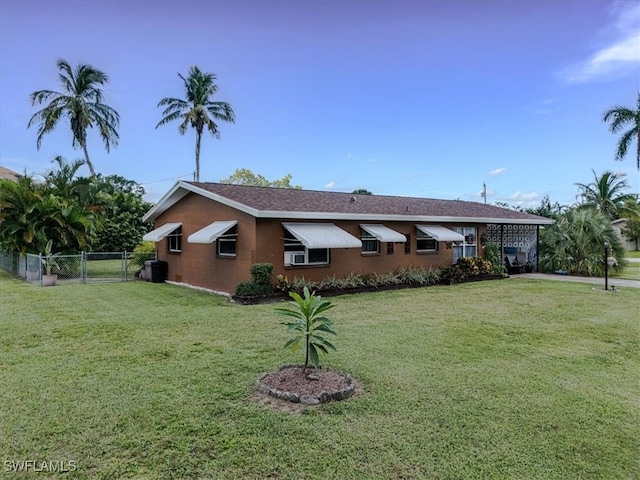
[560,3,640,83]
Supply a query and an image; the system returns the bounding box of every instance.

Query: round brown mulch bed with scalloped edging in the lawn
[256,365,356,405]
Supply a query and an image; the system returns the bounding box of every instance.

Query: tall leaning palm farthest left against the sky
[27,59,120,175]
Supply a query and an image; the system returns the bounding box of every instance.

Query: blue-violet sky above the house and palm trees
[0,0,640,206]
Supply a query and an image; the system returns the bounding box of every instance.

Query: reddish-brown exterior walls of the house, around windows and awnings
[155,194,486,293]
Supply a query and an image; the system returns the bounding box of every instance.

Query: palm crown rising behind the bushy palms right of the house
[576,170,636,220]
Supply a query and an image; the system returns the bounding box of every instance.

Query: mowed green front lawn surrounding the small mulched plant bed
[0,273,640,480]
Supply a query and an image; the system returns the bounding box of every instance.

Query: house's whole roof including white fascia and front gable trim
[144,181,554,225]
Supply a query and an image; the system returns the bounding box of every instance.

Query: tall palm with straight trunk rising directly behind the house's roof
[156,66,235,182]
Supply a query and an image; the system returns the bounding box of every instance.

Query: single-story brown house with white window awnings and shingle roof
[144,181,553,293]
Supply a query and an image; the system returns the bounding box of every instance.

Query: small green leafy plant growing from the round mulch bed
[276,287,336,374]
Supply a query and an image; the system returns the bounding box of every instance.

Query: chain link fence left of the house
[0,252,156,286]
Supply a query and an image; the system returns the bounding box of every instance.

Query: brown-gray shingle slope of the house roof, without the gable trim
[184,182,552,224]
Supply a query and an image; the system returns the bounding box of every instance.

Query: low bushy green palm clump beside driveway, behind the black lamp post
[540,208,624,276]
